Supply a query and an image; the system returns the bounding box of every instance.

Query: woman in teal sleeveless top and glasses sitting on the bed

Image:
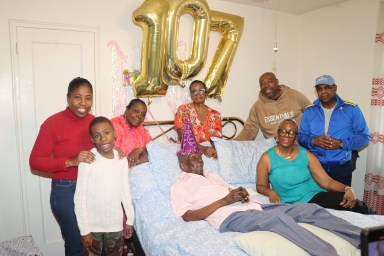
[256,119,375,214]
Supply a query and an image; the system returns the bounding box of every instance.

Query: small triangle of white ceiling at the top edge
[221,0,350,15]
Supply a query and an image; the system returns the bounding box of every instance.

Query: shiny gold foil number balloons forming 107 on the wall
[132,0,244,101]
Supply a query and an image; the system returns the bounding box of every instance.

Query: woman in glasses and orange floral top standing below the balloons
[174,80,222,159]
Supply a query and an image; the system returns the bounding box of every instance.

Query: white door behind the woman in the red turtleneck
[11,21,97,256]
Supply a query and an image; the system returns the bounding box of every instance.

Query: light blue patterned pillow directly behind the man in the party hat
[147,141,218,195]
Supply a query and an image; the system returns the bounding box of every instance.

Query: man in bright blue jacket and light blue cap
[298,75,370,186]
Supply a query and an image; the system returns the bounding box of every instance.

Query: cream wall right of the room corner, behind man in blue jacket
[298,0,380,199]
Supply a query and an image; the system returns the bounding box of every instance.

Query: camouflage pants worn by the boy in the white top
[84,231,124,256]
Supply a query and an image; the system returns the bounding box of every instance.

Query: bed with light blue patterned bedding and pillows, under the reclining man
[129,121,384,256]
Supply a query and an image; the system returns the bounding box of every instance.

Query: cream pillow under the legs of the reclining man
[233,223,360,256]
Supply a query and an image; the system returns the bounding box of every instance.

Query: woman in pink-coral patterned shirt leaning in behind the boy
[111,99,152,167]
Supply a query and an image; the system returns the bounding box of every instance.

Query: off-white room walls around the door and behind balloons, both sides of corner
[0,0,378,241]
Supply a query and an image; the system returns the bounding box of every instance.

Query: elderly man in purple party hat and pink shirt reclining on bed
[171,117,360,255]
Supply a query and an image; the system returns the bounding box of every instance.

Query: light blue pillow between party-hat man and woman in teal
[212,138,276,184]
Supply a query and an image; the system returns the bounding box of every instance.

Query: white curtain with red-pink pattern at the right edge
[364,3,384,214]
